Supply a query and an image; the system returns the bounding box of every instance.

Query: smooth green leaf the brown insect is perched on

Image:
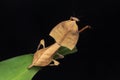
[0,47,77,80]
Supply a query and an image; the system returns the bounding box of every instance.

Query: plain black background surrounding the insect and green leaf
[0,0,120,80]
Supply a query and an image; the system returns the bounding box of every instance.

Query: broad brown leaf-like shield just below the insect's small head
[49,20,79,50]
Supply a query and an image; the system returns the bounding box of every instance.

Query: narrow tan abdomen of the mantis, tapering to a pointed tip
[29,43,61,68]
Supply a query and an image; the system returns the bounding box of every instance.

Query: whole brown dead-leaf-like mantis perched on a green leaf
[28,17,90,68]
